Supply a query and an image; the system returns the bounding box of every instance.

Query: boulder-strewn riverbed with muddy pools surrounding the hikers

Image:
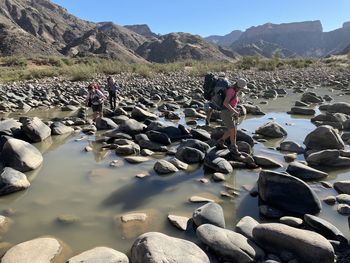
[0,67,350,262]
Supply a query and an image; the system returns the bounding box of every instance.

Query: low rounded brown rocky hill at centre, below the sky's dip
[136,33,232,63]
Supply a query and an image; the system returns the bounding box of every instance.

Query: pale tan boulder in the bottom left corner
[1,237,70,263]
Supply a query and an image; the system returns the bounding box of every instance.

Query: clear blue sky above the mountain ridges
[52,0,350,36]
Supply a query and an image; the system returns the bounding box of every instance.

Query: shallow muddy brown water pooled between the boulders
[0,88,350,253]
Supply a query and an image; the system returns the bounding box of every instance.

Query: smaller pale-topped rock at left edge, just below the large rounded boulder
[0,167,30,195]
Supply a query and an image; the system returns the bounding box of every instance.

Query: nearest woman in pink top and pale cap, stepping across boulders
[218,78,247,155]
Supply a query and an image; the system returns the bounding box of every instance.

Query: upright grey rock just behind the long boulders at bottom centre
[192,202,225,228]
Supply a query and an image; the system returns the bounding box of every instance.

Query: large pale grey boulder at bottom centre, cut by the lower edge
[130,232,210,263]
